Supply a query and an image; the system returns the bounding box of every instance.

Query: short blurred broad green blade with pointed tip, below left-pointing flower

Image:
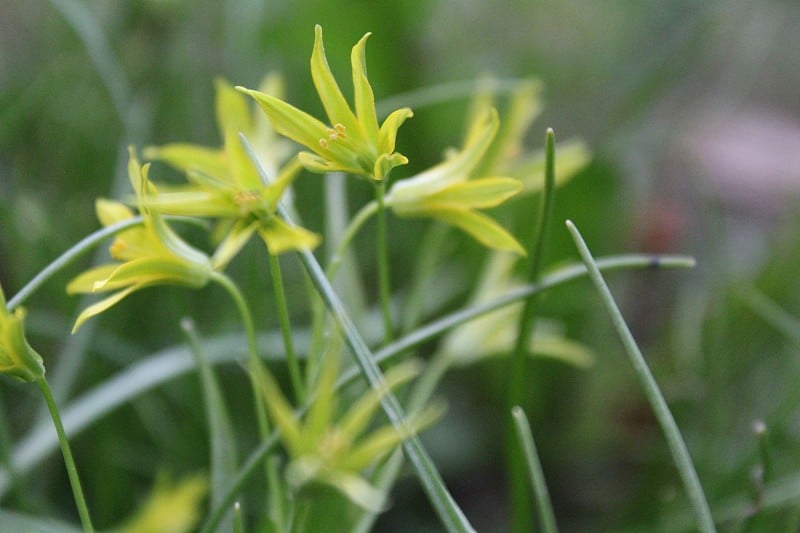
[181,318,238,507]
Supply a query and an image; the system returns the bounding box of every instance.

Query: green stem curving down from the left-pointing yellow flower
[211,272,284,523]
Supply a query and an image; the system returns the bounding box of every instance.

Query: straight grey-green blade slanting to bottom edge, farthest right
[567,220,716,533]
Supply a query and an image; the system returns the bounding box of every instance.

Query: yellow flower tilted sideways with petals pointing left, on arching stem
[67,148,213,333]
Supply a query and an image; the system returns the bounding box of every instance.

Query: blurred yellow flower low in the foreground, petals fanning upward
[261,353,442,511]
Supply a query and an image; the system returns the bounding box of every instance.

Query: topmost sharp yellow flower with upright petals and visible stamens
[237,25,413,181]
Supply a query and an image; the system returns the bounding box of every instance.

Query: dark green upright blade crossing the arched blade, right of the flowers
[506,125,556,533]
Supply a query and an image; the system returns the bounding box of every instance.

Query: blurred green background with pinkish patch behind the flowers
[0,0,800,531]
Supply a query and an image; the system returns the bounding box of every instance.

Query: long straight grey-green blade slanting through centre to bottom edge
[240,134,474,531]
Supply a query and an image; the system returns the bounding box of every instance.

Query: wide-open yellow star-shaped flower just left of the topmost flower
[144,78,319,269]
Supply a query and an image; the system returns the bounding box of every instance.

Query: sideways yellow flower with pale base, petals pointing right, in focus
[385,109,525,255]
